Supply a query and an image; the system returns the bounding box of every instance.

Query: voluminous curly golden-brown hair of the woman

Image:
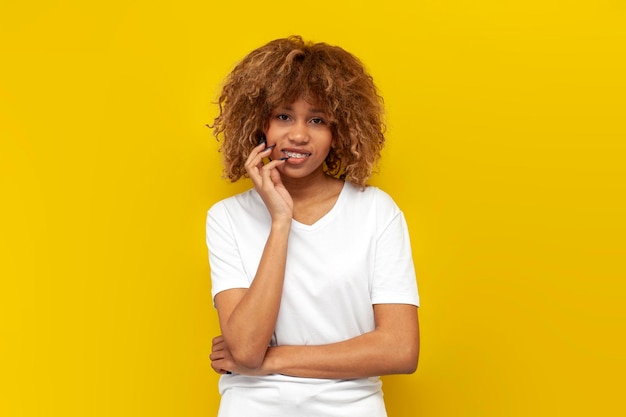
[210,36,385,187]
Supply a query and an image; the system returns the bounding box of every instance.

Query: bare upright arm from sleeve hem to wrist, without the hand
[216,224,290,368]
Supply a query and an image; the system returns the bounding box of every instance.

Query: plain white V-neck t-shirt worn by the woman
[207,182,419,417]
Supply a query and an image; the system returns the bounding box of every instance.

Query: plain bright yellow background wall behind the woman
[0,0,626,417]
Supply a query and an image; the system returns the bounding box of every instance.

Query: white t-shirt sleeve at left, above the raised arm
[206,203,250,299]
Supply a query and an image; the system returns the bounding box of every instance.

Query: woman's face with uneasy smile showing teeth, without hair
[265,99,333,178]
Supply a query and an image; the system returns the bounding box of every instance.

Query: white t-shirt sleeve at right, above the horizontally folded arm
[372,195,419,306]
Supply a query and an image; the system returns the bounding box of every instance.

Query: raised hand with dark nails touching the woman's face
[245,143,293,223]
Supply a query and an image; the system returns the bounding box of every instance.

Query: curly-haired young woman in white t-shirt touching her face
[207,37,419,417]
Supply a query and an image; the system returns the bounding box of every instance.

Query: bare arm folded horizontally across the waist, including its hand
[211,304,420,379]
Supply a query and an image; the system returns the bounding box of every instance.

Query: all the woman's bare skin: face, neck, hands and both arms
[210,99,419,378]
